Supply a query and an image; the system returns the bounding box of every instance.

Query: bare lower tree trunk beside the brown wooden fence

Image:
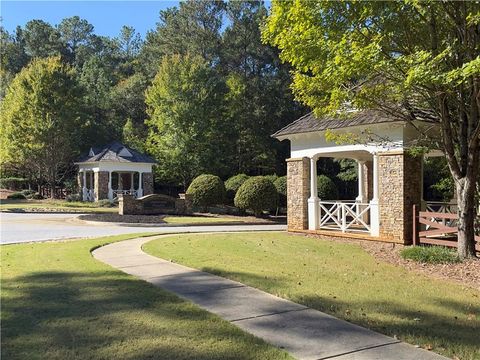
[455,178,477,259]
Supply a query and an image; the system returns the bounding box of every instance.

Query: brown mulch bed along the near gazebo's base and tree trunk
[309,235,480,290]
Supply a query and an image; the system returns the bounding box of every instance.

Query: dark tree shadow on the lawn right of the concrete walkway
[198,267,480,359]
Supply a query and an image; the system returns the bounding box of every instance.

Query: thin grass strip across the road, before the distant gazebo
[0,199,118,213]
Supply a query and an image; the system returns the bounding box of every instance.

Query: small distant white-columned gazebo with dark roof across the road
[75,142,156,201]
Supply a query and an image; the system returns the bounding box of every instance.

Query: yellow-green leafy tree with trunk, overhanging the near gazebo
[263,0,480,258]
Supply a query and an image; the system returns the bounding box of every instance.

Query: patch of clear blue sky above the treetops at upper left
[0,0,179,37]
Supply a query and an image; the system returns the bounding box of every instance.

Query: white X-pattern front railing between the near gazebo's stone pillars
[319,201,371,233]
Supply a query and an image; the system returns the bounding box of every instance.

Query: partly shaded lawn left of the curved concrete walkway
[1,235,288,360]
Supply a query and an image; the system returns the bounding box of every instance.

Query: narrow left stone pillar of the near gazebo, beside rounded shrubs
[287,157,310,230]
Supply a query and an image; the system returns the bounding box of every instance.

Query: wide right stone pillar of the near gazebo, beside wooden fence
[378,152,422,244]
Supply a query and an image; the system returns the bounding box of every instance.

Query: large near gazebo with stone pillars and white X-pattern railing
[272,110,441,243]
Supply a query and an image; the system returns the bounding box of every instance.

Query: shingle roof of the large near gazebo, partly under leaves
[272,110,399,138]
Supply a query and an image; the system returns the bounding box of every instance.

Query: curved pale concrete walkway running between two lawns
[93,236,445,360]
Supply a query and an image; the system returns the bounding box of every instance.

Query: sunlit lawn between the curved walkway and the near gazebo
[144,233,480,359]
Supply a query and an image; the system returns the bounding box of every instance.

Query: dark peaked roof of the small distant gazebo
[77,141,156,164]
